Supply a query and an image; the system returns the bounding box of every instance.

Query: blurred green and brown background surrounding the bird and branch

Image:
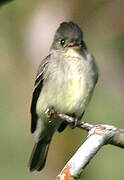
[0,0,124,180]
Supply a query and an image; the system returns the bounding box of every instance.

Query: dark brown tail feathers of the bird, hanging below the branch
[29,139,50,172]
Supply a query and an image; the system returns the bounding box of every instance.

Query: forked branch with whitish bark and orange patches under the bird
[46,109,124,180]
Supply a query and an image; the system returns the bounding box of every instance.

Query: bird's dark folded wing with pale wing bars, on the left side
[30,55,50,133]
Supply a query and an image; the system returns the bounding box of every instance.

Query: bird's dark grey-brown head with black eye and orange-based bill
[51,22,86,51]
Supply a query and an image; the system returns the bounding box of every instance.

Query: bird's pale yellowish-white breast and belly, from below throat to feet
[37,55,93,116]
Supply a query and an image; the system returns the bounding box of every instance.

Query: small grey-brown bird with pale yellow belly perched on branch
[29,21,98,172]
